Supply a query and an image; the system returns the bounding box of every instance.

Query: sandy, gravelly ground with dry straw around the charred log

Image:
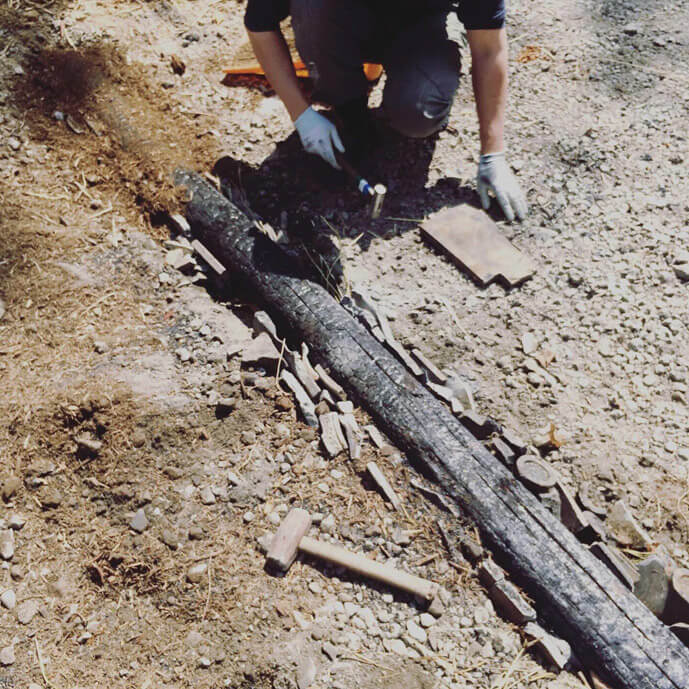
[0,0,689,689]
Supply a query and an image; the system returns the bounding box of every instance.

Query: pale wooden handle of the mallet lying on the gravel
[299,536,438,601]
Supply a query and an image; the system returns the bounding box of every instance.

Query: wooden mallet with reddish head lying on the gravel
[266,508,439,601]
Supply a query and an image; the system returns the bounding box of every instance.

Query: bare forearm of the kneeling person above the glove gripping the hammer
[248,31,309,122]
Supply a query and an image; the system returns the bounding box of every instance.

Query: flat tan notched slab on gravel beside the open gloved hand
[421,204,536,287]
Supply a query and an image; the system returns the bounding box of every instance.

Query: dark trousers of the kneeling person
[290,0,460,137]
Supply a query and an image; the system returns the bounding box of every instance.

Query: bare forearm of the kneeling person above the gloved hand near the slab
[468,29,507,154]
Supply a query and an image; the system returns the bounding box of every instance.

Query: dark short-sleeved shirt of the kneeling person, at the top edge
[244,0,505,31]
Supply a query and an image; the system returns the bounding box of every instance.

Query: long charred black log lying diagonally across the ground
[176,172,689,689]
